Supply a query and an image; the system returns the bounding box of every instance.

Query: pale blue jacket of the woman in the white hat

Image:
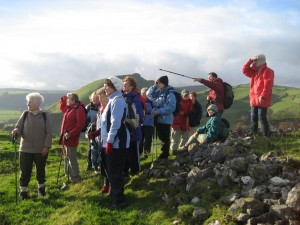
[100,91,130,149]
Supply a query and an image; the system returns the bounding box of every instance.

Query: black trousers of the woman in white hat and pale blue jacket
[106,148,128,203]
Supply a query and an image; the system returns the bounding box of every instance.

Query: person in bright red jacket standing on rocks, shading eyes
[242,54,274,137]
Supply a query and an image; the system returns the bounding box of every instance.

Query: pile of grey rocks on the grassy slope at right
[144,132,300,225]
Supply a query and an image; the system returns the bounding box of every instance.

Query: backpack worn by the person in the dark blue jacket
[124,96,140,133]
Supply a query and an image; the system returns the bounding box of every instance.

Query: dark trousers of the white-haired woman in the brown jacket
[20,152,48,187]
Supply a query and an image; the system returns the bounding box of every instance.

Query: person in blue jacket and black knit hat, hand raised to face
[147,76,176,159]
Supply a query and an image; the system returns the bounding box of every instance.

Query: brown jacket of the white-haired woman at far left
[15,110,52,153]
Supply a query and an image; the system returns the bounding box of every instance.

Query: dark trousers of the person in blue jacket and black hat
[156,123,171,155]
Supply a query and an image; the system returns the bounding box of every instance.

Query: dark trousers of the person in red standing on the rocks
[251,107,270,136]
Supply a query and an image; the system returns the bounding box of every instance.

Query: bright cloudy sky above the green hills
[0,0,300,91]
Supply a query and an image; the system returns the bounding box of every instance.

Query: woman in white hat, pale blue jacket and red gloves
[100,77,130,210]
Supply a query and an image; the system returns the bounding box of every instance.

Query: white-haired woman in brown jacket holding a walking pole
[12,93,52,200]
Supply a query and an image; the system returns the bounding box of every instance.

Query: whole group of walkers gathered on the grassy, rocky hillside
[12,54,274,210]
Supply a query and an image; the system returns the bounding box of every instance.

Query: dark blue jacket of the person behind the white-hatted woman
[123,91,144,141]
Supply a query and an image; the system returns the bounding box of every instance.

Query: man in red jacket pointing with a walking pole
[194,72,224,115]
